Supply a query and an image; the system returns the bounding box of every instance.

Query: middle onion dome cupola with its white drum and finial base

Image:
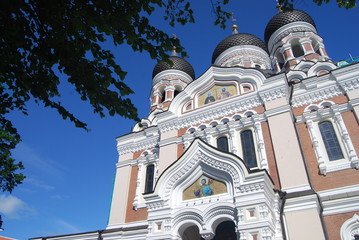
[212,25,271,69]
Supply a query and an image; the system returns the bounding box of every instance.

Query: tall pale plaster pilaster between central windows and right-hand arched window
[268,112,309,192]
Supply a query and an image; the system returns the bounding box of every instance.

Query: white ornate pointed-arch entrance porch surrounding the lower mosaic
[143,138,280,239]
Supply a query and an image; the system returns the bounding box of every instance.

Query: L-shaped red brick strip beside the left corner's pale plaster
[125,166,147,223]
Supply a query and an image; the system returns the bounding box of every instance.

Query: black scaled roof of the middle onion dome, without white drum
[212,33,268,63]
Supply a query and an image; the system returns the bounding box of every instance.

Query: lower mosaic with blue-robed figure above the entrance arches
[182,175,227,200]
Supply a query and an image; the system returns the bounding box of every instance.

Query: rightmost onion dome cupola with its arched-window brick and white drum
[264,6,329,72]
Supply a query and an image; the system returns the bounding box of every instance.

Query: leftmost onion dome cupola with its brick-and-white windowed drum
[150,47,195,111]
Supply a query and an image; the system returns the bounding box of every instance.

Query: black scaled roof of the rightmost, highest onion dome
[264,9,315,42]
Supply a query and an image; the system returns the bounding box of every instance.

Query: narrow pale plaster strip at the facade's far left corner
[108,165,131,227]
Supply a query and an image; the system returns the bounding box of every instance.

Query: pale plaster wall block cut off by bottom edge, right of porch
[285,208,325,240]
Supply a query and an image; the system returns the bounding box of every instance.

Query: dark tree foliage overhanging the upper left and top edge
[0,0,355,192]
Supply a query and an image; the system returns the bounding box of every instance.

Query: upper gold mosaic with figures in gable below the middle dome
[198,85,237,106]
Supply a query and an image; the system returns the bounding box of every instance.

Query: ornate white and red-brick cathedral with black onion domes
[33,7,359,240]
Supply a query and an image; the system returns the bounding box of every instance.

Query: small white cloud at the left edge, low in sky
[0,194,36,218]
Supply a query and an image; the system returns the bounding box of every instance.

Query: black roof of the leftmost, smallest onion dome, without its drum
[152,56,195,79]
